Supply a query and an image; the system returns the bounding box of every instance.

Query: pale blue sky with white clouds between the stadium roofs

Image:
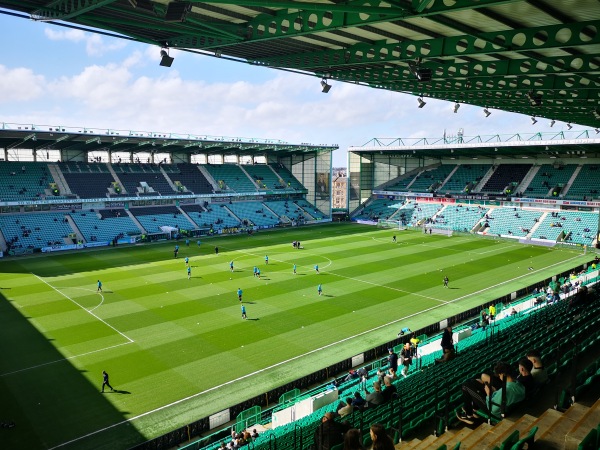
[0,14,586,167]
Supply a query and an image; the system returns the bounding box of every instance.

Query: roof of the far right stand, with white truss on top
[348,131,600,159]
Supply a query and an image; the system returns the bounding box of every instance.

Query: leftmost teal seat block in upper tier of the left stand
[0,161,54,202]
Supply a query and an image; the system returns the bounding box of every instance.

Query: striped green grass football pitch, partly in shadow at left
[0,224,585,449]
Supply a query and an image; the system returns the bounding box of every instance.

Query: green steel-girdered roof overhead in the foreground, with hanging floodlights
[0,0,600,127]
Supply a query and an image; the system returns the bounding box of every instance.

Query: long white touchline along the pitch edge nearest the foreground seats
[49,248,577,450]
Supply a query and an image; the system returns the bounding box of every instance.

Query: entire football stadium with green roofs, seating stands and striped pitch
[0,0,600,450]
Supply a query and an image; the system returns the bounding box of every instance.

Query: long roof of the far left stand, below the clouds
[0,123,338,156]
